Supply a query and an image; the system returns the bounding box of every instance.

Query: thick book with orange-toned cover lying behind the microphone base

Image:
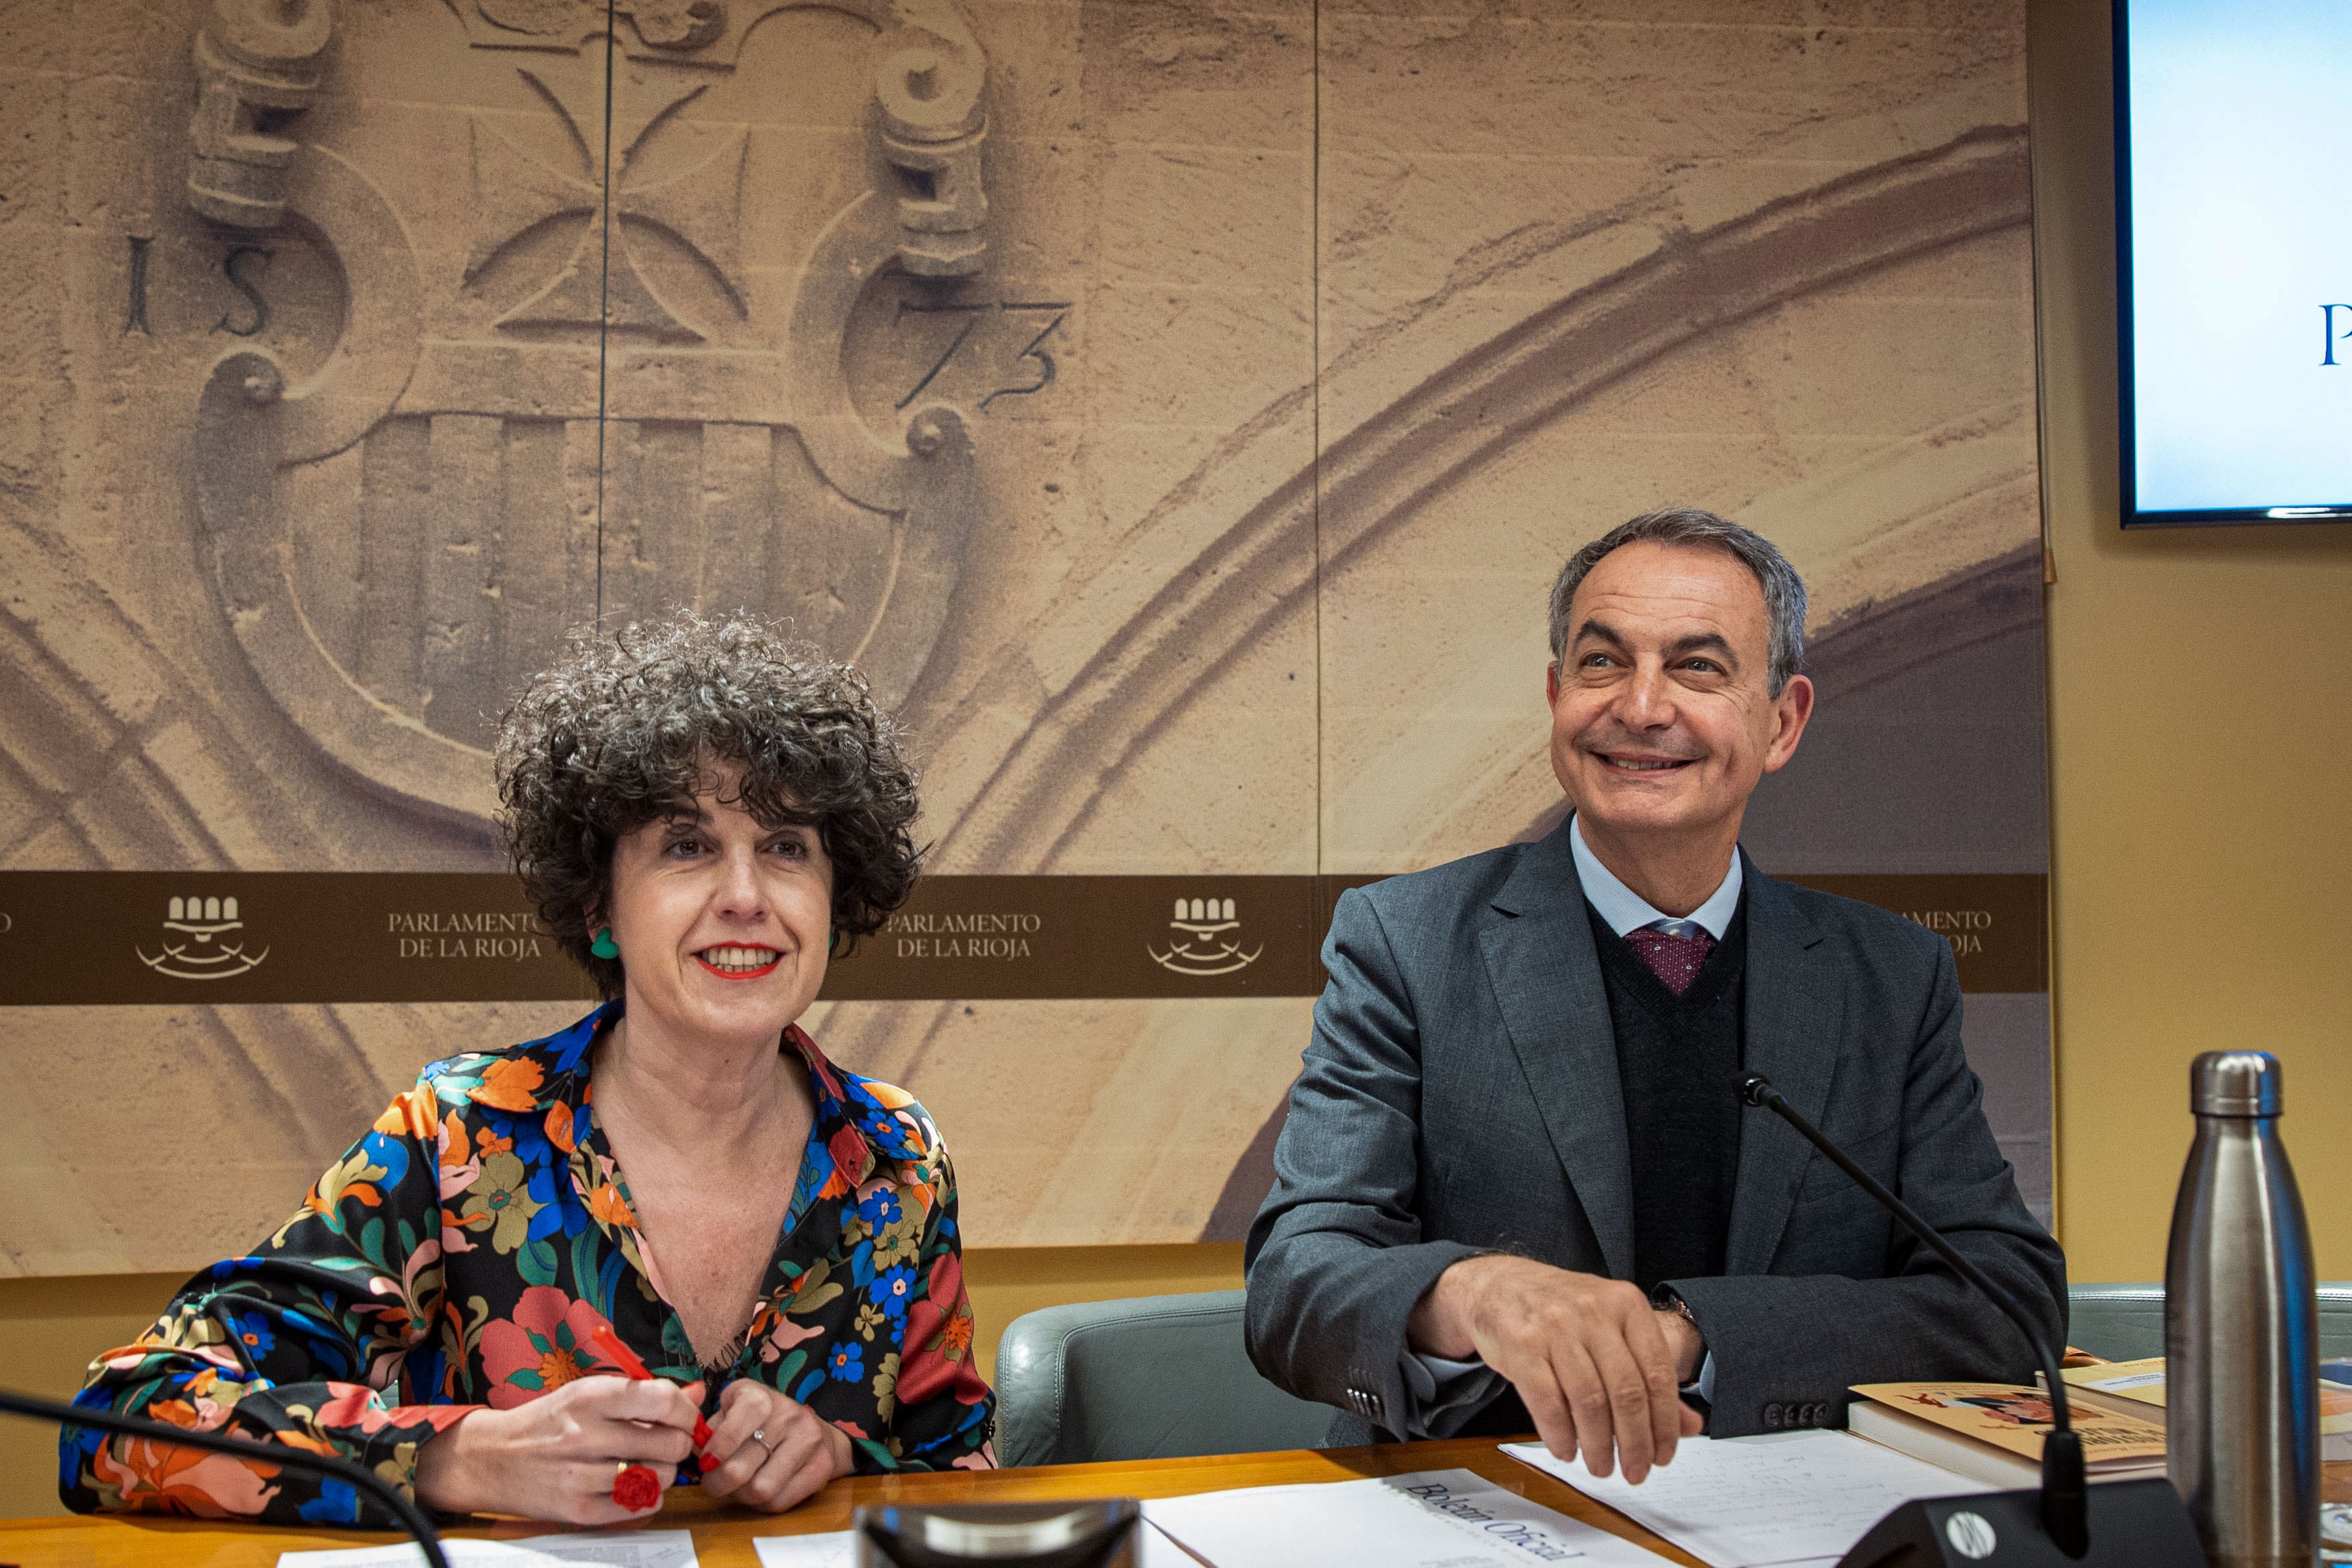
[1847,1382,2164,1488]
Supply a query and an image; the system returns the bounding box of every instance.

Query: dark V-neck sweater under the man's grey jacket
[1586,896,1748,1290]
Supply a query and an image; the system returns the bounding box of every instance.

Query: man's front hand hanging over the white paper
[1407,1256,1705,1483]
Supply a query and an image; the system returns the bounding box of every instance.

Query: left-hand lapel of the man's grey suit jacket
[1479,825,1632,1279]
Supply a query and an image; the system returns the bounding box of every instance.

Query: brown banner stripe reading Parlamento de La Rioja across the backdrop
[0,872,2049,1006]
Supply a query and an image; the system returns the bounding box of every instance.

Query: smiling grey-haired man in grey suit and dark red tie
[1249,510,2065,1481]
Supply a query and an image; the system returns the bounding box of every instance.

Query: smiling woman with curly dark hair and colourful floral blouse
[61,613,995,1523]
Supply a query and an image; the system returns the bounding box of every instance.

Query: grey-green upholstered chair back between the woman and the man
[997,1290,1334,1465]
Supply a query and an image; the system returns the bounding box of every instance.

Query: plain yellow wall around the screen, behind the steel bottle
[2028,0,2352,1279]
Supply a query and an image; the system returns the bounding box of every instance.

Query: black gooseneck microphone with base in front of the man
[1736,1072,2206,1568]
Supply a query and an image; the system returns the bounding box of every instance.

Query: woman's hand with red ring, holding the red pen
[417,1378,698,1526]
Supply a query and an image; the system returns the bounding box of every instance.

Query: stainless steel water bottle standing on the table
[2164,1051,2319,1568]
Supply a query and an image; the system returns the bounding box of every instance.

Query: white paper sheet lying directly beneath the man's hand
[1503,1432,1992,1568]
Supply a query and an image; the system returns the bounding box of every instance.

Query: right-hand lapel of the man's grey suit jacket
[1724,851,1847,1274]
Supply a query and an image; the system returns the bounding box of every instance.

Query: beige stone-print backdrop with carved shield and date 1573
[0,0,2049,1274]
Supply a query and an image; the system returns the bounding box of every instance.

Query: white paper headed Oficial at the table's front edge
[1143,1469,1665,1568]
